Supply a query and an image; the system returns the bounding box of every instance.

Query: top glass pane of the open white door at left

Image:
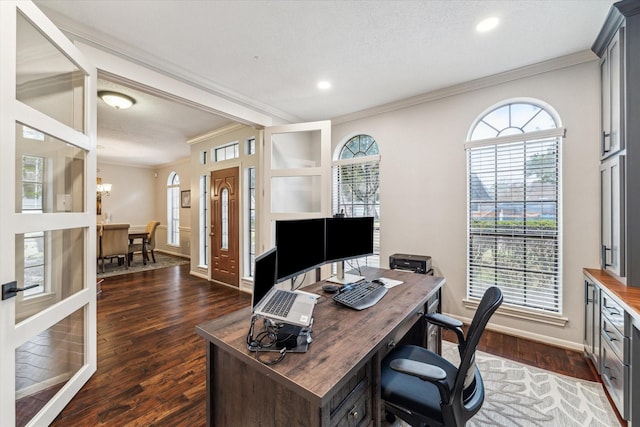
[16,14,86,132]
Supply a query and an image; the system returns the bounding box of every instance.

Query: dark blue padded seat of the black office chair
[381,345,458,424]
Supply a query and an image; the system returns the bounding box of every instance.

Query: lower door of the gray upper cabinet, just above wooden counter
[600,155,625,276]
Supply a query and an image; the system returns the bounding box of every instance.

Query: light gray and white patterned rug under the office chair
[384,341,620,427]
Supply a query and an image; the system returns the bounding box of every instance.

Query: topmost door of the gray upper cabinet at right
[600,27,624,158]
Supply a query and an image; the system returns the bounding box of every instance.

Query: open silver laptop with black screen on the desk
[252,248,317,327]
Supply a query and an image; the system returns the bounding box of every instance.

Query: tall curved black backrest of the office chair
[452,286,503,421]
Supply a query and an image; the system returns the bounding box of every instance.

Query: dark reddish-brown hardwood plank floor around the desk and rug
[52,265,597,427]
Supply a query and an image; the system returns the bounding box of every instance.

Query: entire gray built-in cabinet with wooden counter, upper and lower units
[584,0,640,425]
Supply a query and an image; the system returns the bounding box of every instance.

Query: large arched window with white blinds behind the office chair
[465,101,564,313]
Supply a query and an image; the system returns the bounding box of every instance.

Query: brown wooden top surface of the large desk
[196,268,445,405]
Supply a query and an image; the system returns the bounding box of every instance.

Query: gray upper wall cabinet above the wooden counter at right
[592,0,640,286]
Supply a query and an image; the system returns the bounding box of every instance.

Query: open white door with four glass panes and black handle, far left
[0,1,96,426]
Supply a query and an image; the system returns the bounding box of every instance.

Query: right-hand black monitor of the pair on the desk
[325,216,373,262]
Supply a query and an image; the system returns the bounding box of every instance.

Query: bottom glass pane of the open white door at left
[16,308,86,426]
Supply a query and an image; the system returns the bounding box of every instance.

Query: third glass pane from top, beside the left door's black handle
[16,228,86,323]
